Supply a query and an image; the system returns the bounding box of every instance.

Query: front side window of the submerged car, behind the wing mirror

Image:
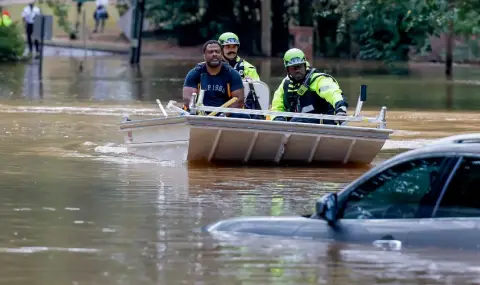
[340,157,446,219]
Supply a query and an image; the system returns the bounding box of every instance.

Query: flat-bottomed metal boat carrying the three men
[120,82,392,164]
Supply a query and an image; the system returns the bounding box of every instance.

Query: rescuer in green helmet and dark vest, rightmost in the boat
[271,48,348,125]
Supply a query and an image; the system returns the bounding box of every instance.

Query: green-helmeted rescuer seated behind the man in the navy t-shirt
[218,32,260,80]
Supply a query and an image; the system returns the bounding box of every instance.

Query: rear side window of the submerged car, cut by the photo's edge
[435,157,480,218]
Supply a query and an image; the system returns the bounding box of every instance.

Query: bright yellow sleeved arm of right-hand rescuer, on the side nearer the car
[310,76,348,115]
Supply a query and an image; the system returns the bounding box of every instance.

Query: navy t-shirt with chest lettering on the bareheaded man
[183,64,243,107]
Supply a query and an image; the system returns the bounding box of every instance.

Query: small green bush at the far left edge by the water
[0,24,25,61]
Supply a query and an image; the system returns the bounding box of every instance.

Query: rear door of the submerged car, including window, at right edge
[408,155,480,250]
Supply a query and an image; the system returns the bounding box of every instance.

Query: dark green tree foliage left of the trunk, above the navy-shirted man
[145,0,261,54]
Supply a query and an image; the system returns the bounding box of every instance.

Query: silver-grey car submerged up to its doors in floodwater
[205,134,480,250]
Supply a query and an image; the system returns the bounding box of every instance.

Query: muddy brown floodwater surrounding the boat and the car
[0,51,480,285]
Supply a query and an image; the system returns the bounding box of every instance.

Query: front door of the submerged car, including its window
[316,155,453,247]
